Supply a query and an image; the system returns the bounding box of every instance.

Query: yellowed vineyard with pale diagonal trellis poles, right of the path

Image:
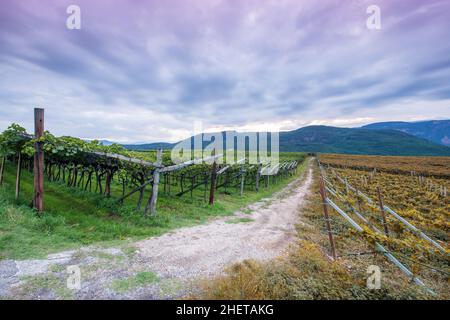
[319,155,450,292]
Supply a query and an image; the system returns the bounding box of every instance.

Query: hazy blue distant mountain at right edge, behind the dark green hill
[362,120,450,146]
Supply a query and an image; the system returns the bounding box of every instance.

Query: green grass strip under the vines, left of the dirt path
[0,156,305,259]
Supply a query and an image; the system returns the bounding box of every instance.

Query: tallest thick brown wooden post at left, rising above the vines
[33,108,44,213]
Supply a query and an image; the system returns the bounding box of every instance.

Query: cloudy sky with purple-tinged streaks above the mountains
[0,0,450,142]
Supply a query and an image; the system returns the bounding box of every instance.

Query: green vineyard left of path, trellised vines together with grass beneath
[0,113,306,258]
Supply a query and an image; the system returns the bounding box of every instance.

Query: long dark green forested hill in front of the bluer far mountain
[121,126,450,156]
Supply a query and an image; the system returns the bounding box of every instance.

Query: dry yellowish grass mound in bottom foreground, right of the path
[191,240,423,300]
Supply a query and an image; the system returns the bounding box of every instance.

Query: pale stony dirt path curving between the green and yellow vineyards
[0,163,312,299]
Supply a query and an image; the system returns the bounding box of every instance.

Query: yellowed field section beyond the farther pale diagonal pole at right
[320,155,450,238]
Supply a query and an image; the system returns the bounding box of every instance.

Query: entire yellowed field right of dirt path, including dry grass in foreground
[199,155,450,299]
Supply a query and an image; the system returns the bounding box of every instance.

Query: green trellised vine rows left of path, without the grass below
[0,124,301,214]
